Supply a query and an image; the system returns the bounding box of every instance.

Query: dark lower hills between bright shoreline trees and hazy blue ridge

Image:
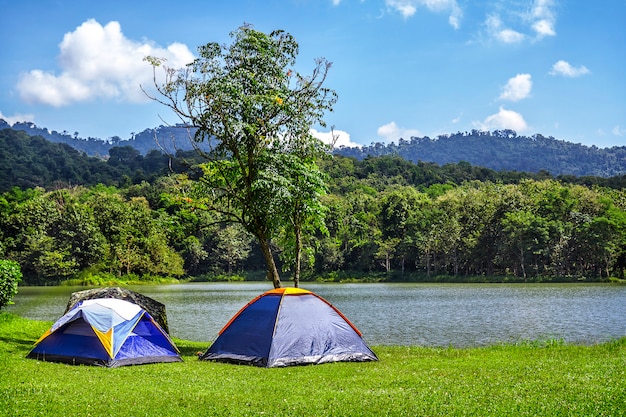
[0,129,626,196]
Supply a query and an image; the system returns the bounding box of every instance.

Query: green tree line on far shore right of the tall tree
[318,180,626,280]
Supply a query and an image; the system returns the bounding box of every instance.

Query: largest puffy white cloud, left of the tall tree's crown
[17,19,193,107]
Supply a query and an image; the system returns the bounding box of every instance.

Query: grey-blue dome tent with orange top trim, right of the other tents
[200,288,378,368]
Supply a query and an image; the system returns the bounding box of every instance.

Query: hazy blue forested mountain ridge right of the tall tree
[337,130,626,177]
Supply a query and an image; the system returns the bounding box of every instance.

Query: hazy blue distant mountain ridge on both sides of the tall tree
[0,119,626,178]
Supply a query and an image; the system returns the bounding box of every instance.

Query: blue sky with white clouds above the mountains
[0,0,626,147]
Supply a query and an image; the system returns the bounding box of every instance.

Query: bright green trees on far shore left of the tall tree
[0,187,184,284]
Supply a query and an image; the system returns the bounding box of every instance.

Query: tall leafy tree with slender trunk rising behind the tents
[147,26,336,287]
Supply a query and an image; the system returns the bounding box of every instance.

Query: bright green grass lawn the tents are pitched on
[0,314,626,417]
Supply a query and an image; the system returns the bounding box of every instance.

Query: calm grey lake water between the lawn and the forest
[6,282,626,347]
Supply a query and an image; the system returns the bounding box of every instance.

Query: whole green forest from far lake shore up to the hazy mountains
[0,130,626,285]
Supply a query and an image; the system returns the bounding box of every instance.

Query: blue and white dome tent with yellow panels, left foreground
[27,298,182,368]
